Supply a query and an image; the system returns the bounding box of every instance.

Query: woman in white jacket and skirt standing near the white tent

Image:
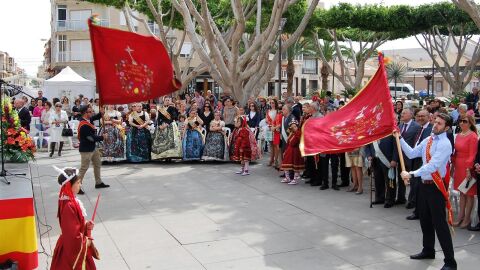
[48,102,68,157]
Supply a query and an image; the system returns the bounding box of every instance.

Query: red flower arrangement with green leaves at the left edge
[1,97,36,162]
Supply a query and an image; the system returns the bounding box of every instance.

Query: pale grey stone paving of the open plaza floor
[31,151,480,270]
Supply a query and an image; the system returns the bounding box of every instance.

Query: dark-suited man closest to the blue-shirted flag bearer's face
[406,110,433,220]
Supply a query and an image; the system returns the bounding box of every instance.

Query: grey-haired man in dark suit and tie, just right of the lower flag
[386,108,421,208]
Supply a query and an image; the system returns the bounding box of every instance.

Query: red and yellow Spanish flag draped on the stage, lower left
[0,198,38,269]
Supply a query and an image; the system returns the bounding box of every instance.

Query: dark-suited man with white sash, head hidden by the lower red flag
[365,136,398,208]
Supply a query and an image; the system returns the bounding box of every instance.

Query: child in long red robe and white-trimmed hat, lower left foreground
[50,167,98,270]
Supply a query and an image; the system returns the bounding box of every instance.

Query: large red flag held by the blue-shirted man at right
[300,55,397,156]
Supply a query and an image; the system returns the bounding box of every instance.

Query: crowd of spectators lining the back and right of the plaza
[14,86,480,270]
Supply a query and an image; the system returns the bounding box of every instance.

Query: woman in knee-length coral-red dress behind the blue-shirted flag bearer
[452,115,478,228]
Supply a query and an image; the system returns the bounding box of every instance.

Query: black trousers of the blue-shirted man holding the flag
[418,183,457,267]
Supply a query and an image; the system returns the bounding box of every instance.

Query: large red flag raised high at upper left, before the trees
[88,15,181,104]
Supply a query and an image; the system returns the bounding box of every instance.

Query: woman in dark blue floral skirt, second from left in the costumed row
[127,103,151,162]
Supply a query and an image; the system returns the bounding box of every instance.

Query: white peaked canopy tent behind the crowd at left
[43,66,95,102]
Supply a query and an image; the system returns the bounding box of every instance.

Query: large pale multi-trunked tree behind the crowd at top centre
[172,0,318,104]
